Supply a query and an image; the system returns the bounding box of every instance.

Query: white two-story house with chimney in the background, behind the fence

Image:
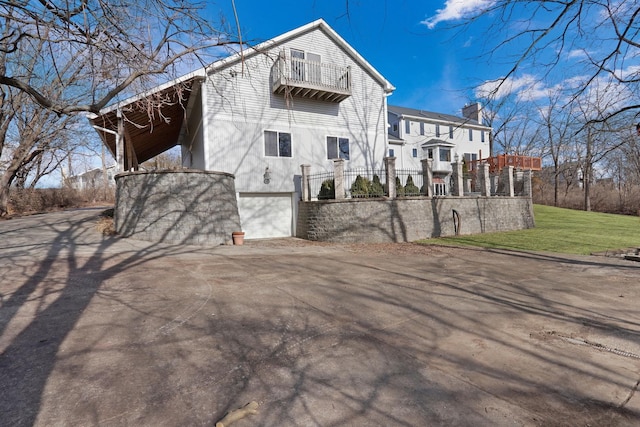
[388,103,491,186]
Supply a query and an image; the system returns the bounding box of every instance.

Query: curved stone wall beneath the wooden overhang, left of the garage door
[114,169,241,245]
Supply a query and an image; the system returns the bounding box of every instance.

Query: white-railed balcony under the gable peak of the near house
[271,54,351,102]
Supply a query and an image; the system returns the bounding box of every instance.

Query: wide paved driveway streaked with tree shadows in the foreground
[0,210,640,427]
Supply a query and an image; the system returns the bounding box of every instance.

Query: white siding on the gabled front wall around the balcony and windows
[200,28,387,192]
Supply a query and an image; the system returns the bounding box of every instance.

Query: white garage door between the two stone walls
[238,193,293,239]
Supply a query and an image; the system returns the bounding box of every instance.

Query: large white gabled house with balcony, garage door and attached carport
[91,20,395,238]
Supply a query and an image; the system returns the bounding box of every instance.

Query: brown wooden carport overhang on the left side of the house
[89,76,202,172]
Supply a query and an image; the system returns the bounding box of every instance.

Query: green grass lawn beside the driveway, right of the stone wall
[420,205,640,255]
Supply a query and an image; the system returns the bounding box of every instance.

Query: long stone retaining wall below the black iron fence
[297,196,535,243]
